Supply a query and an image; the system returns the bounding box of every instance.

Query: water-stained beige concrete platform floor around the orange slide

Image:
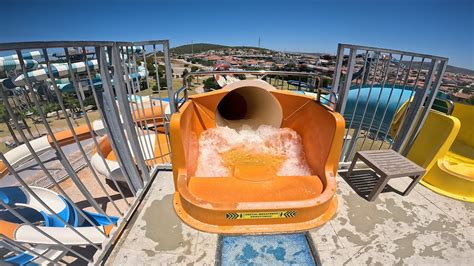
[106,172,474,265]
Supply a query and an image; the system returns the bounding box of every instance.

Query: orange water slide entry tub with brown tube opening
[171,80,344,234]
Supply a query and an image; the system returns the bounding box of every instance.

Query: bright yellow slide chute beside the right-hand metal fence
[399,103,474,202]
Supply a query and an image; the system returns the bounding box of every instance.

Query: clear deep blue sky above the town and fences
[0,0,474,69]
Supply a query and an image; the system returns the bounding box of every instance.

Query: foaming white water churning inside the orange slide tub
[195,125,311,177]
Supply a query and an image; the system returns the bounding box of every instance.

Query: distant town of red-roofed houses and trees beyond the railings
[173,44,474,102]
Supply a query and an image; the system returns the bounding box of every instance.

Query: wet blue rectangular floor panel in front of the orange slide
[216,233,321,266]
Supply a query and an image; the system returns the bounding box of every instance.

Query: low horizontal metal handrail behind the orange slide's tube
[174,70,335,110]
